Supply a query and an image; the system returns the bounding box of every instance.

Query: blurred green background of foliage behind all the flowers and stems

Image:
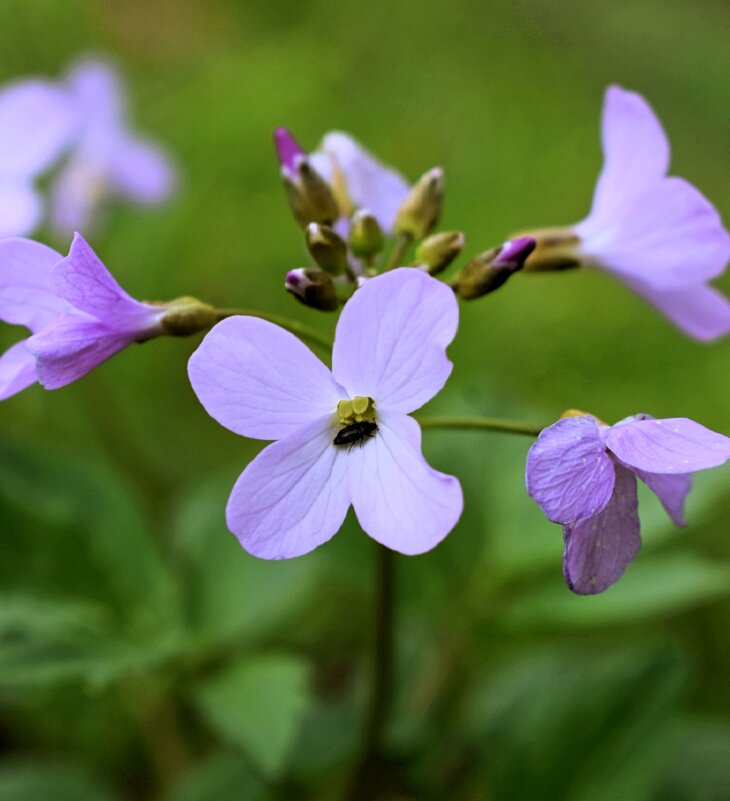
[0,0,730,801]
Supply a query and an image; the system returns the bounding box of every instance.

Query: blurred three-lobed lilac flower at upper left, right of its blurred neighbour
[52,60,175,234]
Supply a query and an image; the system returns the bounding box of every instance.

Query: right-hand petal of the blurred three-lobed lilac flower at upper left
[109,137,175,203]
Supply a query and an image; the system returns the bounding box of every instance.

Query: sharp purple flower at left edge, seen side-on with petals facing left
[0,234,166,400]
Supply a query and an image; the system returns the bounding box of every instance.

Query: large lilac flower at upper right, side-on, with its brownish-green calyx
[525,86,730,340]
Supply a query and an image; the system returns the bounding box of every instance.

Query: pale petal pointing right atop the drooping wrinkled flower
[606,417,730,473]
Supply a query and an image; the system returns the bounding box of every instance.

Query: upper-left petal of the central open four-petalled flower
[188,317,345,439]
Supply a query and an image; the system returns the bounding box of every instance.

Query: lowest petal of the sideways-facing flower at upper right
[624,279,730,342]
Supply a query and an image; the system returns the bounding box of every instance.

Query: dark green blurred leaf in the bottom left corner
[0,761,116,801]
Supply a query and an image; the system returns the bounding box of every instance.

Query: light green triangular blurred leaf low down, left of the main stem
[197,654,311,777]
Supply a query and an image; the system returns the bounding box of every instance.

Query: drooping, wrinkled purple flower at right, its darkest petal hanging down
[526,414,730,595]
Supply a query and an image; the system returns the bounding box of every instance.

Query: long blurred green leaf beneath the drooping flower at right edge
[502,552,730,629]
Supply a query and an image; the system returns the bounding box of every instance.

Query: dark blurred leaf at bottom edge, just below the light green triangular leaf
[164,753,272,801]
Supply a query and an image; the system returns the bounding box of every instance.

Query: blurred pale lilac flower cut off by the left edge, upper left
[0,80,75,238]
